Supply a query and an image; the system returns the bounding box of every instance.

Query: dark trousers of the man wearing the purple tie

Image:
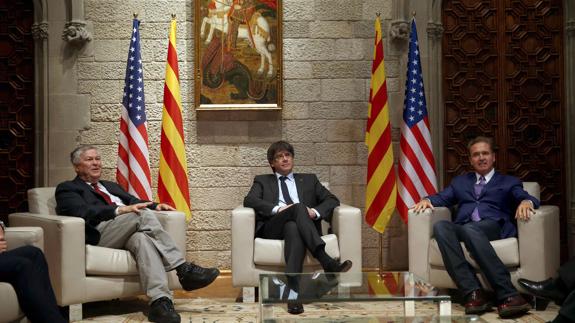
[433,219,518,301]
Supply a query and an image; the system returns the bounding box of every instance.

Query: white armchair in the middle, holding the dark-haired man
[232,205,362,300]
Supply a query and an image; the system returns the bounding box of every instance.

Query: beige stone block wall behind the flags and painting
[76,0,410,269]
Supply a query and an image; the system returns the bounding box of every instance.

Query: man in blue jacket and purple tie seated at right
[414,137,539,318]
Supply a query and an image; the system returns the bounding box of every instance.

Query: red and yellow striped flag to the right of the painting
[365,16,397,233]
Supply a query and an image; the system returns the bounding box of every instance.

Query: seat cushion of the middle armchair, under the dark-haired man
[254,234,340,266]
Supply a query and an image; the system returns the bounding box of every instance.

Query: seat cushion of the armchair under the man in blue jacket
[429,238,519,269]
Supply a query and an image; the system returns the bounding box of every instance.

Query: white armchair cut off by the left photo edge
[0,227,44,323]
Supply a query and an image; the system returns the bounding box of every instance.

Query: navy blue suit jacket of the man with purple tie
[428,172,539,239]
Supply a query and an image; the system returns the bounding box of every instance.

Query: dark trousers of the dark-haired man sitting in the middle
[262,203,325,273]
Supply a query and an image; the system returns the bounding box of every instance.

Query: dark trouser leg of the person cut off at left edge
[0,246,67,323]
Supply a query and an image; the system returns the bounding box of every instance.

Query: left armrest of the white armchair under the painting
[232,206,256,287]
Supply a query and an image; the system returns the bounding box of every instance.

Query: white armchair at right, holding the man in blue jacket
[408,182,559,290]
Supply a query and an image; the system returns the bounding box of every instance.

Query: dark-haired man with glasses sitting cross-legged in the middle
[244,141,352,314]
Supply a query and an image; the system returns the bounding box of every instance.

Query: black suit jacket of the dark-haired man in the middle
[244,174,339,236]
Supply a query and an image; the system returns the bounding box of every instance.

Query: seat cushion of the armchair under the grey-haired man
[86,245,138,276]
